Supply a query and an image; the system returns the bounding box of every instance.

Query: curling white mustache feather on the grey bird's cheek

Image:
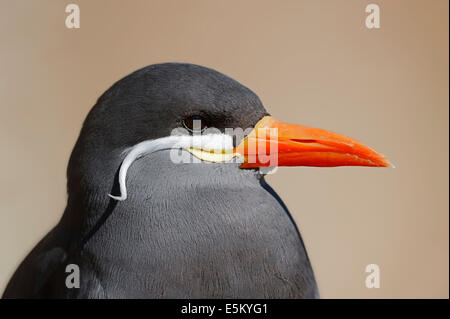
[108,134,233,201]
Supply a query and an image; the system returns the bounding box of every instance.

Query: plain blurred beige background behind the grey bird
[0,0,449,298]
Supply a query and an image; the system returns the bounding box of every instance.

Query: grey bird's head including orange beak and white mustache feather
[69,63,390,200]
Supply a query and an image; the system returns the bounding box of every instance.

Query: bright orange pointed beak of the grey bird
[235,116,391,168]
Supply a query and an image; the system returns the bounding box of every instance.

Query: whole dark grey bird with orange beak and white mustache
[3,63,389,298]
